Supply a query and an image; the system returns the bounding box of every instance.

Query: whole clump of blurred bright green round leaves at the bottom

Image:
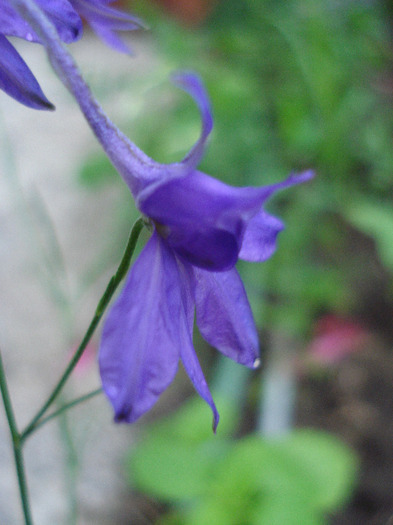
[128,399,357,525]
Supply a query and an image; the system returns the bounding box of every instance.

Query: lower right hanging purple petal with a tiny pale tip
[194,268,259,368]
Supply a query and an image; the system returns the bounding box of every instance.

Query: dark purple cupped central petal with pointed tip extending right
[137,171,312,271]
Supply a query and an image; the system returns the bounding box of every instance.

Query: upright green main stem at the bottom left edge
[0,351,33,525]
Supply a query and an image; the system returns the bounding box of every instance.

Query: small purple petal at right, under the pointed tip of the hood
[239,210,284,262]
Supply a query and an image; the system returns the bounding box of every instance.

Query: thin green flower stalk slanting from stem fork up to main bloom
[20,218,144,441]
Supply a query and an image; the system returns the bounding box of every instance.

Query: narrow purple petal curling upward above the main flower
[172,72,213,172]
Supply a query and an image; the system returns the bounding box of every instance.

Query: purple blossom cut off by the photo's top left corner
[0,0,142,109]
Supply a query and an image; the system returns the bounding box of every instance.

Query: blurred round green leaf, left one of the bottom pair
[128,397,237,501]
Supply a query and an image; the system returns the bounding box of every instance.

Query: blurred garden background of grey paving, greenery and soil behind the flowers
[0,0,393,525]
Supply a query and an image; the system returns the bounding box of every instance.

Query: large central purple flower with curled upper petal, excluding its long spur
[99,73,312,429]
